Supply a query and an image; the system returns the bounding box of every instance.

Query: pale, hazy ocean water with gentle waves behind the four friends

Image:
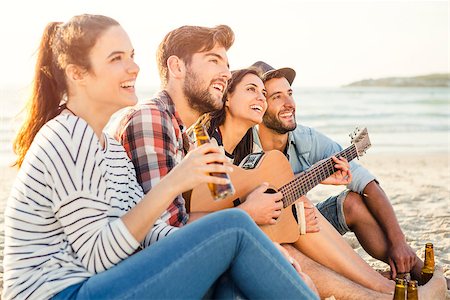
[0,87,450,167]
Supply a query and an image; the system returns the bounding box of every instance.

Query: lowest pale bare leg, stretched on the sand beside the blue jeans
[283,244,394,300]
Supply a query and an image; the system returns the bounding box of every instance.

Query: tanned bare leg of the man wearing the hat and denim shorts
[344,192,423,279]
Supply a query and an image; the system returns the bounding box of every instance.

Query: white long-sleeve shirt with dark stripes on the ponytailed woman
[2,114,176,299]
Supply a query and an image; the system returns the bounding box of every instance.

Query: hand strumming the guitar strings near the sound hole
[238,182,283,225]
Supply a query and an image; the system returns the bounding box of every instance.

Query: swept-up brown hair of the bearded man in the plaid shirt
[156,25,234,88]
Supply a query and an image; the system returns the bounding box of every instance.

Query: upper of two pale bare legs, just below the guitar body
[293,209,395,293]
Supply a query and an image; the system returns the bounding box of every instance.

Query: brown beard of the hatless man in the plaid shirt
[183,69,223,114]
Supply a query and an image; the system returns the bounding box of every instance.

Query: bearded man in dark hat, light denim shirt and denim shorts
[252,61,423,278]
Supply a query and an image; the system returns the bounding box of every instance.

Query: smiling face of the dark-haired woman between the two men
[225,73,267,128]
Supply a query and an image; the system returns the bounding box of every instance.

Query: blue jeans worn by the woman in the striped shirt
[53,209,318,299]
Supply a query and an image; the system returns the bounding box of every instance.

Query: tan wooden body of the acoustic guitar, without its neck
[190,151,300,243]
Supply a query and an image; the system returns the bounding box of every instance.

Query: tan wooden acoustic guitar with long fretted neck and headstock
[190,128,371,243]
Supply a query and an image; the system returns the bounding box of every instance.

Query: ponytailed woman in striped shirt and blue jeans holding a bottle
[2,15,317,299]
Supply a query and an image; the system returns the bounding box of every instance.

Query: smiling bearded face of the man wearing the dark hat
[263,77,297,134]
